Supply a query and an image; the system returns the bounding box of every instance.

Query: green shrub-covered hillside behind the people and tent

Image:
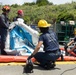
[9,0,76,24]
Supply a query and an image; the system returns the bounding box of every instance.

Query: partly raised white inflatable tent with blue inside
[5,19,42,55]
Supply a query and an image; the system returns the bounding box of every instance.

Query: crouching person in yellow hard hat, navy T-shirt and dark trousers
[27,20,61,69]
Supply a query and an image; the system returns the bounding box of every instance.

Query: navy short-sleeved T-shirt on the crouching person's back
[39,31,59,51]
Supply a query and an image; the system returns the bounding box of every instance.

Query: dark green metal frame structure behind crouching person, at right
[56,23,76,42]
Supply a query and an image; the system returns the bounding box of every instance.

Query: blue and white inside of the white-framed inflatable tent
[10,25,35,52]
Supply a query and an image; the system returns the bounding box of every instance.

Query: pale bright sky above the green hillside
[0,0,76,5]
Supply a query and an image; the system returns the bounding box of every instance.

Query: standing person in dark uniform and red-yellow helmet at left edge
[0,5,10,55]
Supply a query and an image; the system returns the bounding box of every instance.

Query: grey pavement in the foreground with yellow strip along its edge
[0,61,76,75]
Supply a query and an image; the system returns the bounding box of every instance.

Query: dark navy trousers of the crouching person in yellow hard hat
[34,50,61,65]
